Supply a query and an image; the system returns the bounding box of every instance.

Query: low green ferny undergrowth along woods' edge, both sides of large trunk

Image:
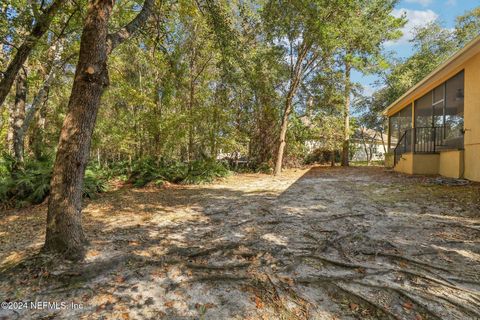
[0,154,230,208]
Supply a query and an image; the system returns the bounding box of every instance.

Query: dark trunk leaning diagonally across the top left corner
[0,0,66,107]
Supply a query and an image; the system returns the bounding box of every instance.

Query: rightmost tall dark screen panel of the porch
[444,71,464,148]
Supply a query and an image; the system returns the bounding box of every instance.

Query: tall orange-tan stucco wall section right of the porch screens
[464,54,480,181]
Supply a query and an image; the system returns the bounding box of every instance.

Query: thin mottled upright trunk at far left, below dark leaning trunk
[12,71,27,171]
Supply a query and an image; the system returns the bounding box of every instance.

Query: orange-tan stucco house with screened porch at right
[384,37,480,181]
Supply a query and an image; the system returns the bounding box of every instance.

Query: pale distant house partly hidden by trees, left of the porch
[351,127,388,162]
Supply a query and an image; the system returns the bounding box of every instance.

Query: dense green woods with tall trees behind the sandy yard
[0,0,480,319]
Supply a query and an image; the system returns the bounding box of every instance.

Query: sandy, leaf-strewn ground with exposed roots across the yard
[0,167,480,320]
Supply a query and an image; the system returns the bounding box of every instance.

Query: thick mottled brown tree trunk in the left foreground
[44,0,113,260]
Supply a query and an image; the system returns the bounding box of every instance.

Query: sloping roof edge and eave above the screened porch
[383,36,480,115]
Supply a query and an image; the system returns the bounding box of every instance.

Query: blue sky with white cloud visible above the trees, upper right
[352,0,480,95]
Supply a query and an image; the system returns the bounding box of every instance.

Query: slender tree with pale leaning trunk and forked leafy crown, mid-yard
[264,0,353,175]
